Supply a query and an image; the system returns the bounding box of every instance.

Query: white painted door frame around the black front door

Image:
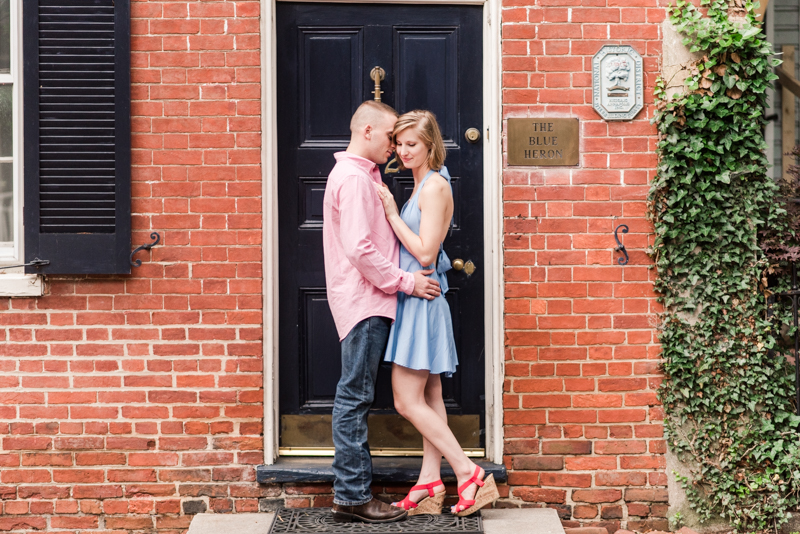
[260,0,505,465]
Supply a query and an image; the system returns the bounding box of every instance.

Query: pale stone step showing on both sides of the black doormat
[187,508,564,534]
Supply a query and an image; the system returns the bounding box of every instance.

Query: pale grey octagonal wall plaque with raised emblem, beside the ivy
[592,45,644,121]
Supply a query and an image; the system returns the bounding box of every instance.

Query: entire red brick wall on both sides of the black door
[0,0,666,532]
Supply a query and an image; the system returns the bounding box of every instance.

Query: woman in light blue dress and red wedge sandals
[378,110,499,516]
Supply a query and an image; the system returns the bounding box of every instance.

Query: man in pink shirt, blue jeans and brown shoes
[322,101,440,523]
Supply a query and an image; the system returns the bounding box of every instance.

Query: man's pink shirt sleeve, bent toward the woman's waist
[339,176,414,295]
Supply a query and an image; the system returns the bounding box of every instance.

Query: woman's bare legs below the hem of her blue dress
[392,364,484,510]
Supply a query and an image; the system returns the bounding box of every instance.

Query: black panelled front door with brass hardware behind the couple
[277,2,485,454]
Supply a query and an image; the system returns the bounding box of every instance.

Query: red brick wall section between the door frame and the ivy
[502,0,667,531]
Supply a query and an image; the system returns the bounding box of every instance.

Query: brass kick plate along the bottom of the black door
[280,414,483,456]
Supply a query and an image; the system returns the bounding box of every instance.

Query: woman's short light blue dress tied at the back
[384,167,458,376]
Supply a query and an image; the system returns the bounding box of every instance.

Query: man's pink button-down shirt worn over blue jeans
[322,152,414,341]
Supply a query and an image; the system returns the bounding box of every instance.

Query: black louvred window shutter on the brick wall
[23,0,131,274]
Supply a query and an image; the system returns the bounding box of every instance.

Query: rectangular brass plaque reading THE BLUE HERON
[507,118,580,167]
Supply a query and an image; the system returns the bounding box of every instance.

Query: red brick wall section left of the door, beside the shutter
[0,0,268,532]
